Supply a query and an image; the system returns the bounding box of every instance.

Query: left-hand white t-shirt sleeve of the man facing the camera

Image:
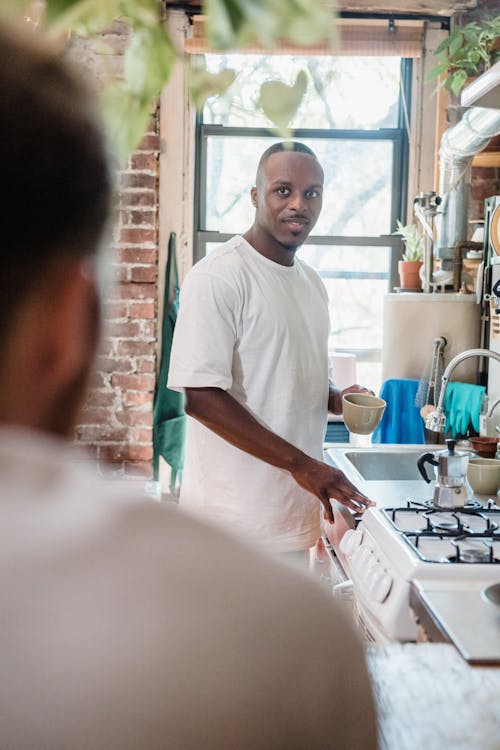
[168,271,237,390]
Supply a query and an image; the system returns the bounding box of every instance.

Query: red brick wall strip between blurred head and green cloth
[76,116,160,478]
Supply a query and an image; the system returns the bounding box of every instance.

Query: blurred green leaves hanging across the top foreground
[6,0,335,164]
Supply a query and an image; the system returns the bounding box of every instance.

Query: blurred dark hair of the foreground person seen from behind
[0,29,111,335]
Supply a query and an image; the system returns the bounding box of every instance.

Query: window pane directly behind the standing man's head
[205,136,393,237]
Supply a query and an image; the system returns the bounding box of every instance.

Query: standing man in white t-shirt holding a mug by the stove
[169,142,371,552]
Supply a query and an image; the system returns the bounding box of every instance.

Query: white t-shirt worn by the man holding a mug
[168,236,329,551]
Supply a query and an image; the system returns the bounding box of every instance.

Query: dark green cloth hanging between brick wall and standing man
[153,232,186,492]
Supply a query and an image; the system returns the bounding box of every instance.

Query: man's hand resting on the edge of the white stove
[292,456,375,523]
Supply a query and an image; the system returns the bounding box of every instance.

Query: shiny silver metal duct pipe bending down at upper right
[434,63,500,268]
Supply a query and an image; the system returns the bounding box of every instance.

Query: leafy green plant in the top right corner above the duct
[428,15,500,95]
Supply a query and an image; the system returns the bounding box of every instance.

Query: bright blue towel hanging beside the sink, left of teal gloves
[372,378,425,443]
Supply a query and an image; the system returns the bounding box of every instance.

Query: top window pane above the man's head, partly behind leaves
[203,55,401,130]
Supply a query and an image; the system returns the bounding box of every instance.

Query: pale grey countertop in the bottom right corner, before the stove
[368,643,500,750]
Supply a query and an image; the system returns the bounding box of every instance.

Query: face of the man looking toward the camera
[252,151,324,250]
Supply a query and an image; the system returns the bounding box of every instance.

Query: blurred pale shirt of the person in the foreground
[0,428,376,750]
